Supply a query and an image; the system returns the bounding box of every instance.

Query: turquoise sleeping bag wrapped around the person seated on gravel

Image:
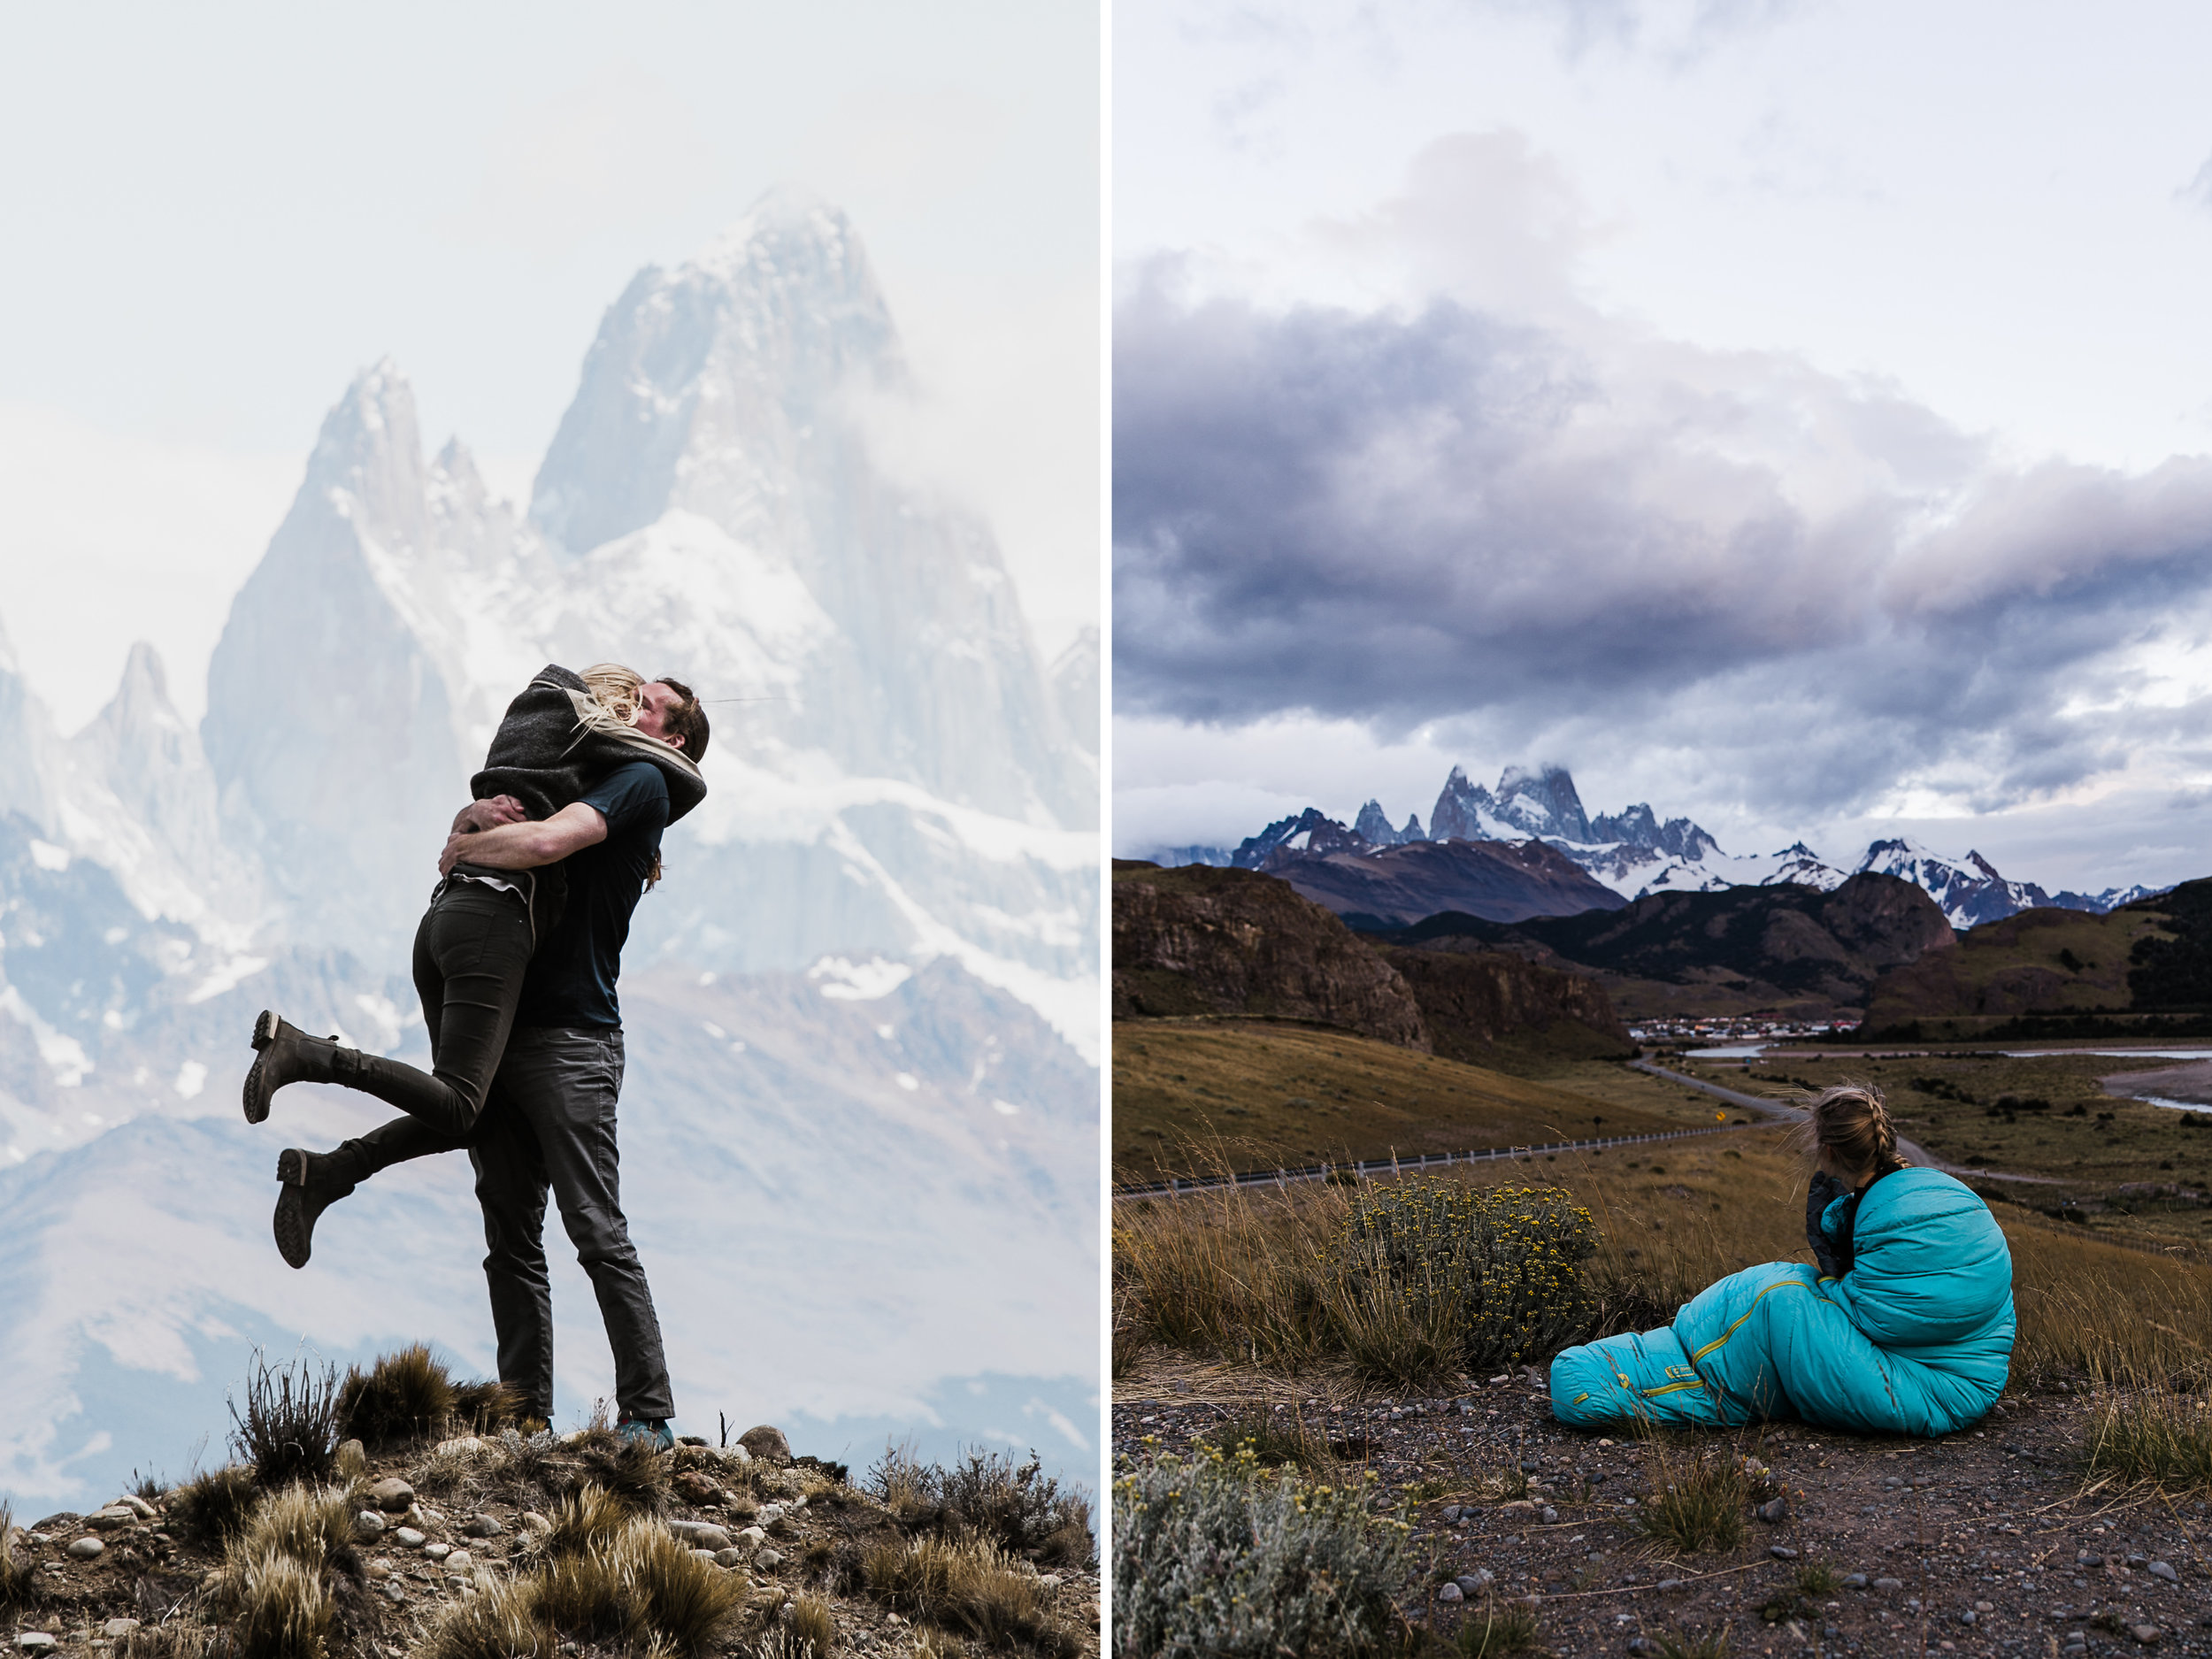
[1551,1168,2016,1436]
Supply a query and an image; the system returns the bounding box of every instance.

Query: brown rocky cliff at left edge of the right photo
[1113,861,1429,1051]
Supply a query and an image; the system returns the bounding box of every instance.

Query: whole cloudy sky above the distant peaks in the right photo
[1113,0,2212,885]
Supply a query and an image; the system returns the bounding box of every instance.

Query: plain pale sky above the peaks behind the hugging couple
[0,0,1100,730]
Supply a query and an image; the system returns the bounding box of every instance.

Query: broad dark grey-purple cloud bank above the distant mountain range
[1115,273,2212,805]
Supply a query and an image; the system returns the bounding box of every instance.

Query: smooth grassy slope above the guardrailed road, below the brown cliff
[1113,1020,1715,1181]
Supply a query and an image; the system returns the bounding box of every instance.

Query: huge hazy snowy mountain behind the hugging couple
[0,195,1100,1509]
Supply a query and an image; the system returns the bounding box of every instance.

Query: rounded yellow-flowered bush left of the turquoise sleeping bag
[1327,1177,1597,1383]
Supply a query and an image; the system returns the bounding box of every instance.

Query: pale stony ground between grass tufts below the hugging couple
[0,1429,1100,1659]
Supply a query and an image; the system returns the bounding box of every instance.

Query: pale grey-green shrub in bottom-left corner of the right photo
[1113,1449,1411,1659]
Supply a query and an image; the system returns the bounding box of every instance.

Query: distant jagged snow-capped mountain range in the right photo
[1155,765,2159,929]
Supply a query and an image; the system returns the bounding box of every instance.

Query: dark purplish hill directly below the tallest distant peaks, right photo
[1261,841,1628,927]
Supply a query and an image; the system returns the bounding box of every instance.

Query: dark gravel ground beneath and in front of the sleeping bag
[1113,1370,2212,1659]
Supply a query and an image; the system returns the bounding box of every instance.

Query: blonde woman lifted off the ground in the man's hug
[243,664,708,1268]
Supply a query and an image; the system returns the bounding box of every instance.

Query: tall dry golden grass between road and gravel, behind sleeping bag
[1113,1131,2212,1380]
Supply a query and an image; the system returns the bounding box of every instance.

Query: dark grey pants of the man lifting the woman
[469,1026,677,1420]
